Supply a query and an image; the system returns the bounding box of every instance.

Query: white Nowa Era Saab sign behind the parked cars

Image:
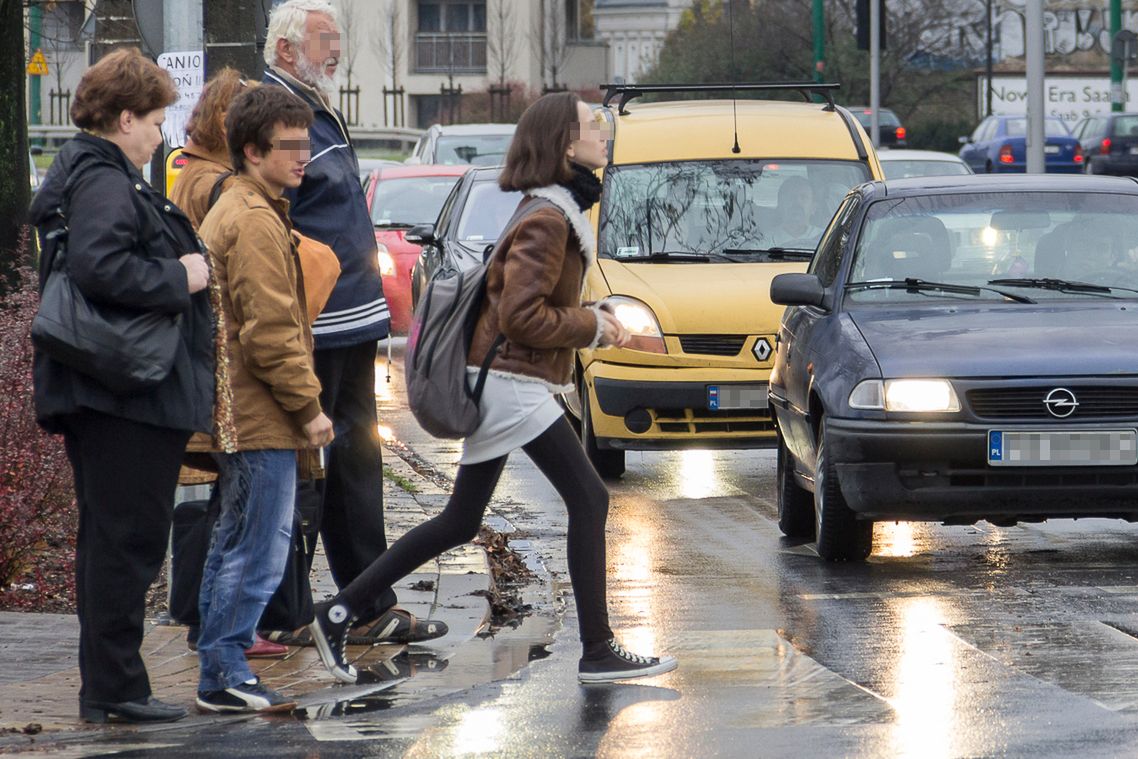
[976,74,1138,126]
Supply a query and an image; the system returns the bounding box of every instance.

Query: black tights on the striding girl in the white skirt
[337,416,612,644]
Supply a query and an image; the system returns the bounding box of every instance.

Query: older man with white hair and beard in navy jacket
[264,0,446,655]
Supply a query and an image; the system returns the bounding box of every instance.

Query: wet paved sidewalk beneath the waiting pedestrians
[0,451,490,737]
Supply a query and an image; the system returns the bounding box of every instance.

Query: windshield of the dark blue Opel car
[846,191,1138,303]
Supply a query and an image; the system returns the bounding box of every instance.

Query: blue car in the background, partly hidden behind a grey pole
[960,116,1083,174]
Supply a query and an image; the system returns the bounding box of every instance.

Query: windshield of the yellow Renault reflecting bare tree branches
[599,159,869,263]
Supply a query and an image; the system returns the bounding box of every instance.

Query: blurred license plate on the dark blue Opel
[988,429,1138,467]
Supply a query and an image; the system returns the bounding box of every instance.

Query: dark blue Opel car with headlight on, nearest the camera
[769,175,1138,560]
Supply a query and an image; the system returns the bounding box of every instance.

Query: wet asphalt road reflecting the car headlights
[28,348,1138,758]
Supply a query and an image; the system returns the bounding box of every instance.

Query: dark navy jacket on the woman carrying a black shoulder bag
[31,134,214,432]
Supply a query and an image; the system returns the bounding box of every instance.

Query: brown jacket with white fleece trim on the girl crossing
[467,188,600,390]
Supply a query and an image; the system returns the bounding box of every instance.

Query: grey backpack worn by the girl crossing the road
[404,199,553,439]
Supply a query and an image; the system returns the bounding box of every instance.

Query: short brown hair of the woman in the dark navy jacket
[71,48,178,132]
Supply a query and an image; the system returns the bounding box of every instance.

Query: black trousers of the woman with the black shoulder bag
[64,411,190,702]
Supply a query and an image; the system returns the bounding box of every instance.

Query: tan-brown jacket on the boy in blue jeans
[199,174,321,451]
